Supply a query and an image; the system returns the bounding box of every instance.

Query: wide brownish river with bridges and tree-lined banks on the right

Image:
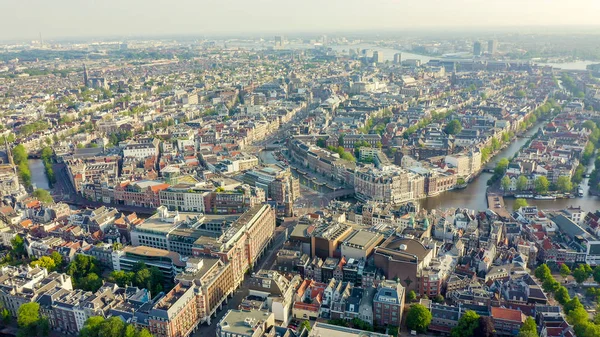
[420,122,600,211]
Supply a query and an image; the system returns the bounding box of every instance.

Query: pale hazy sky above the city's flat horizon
[0,0,600,40]
